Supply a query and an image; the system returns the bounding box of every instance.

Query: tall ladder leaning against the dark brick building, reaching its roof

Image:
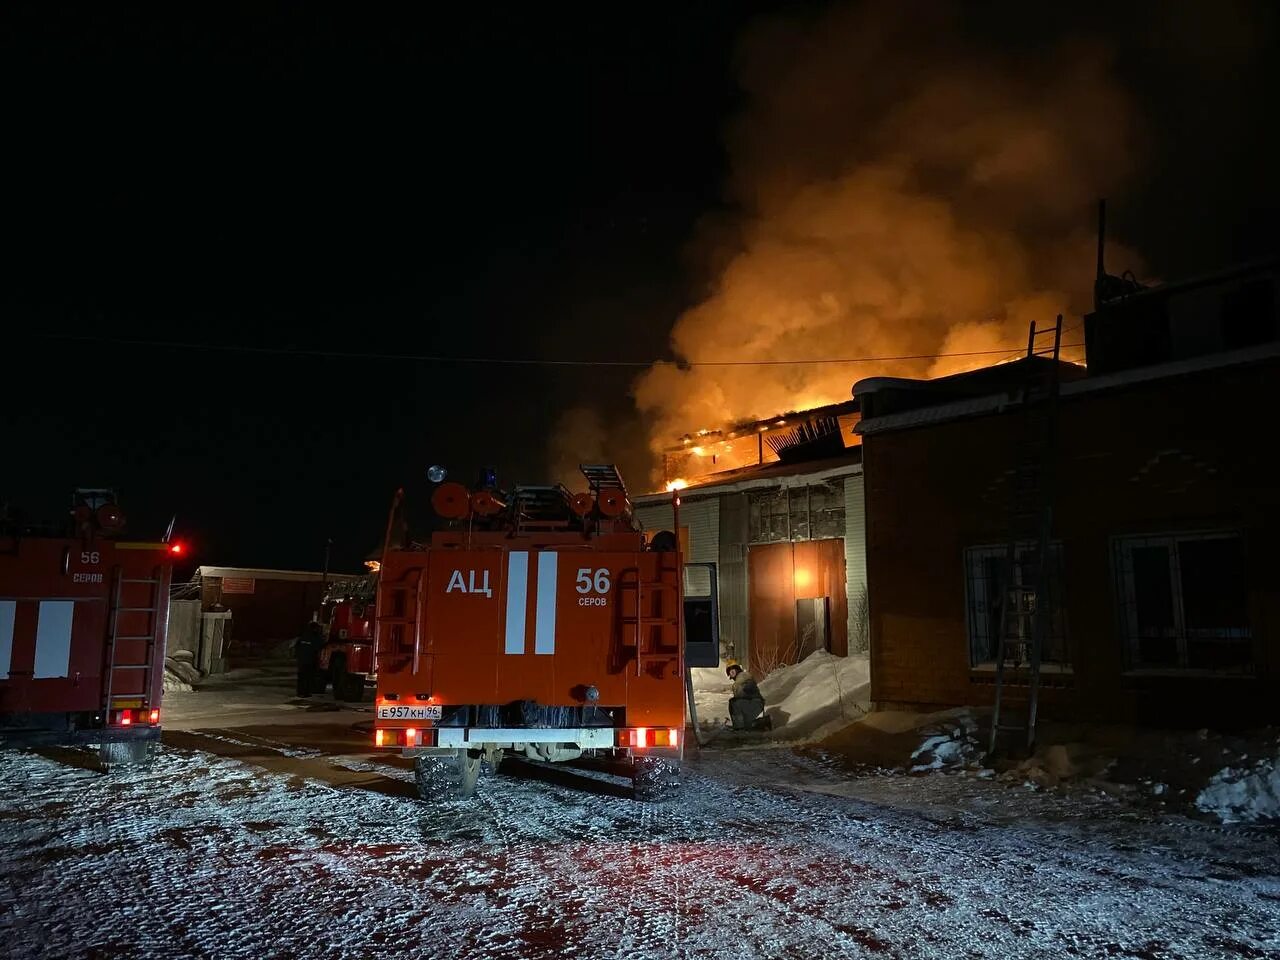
[988,314,1062,754]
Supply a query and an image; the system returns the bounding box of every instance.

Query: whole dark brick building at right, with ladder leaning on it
[854,257,1280,727]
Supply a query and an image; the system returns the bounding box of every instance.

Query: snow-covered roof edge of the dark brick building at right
[854,342,1280,436]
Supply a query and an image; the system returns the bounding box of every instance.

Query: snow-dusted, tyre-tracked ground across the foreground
[0,733,1280,960]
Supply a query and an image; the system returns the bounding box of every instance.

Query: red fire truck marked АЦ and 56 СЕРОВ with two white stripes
[374,465,719,801]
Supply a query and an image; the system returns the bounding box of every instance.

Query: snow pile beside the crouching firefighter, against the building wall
[760,650,870,737]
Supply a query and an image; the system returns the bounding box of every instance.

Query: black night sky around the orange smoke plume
[0,0,1277,568]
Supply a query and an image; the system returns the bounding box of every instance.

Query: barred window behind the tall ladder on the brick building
[964,543,1070,667]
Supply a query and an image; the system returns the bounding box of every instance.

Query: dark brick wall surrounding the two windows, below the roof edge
[864,361,1280,726]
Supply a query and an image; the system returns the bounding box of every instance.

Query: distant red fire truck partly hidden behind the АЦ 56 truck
[298,573,378,701]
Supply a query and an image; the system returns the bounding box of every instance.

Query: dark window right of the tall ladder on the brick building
[1112,532,1253,673]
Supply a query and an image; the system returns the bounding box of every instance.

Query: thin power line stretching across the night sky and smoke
[32,333,1084,369]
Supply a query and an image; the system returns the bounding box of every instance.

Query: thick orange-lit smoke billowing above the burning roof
[635,4,1135,458]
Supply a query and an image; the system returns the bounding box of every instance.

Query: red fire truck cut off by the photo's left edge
[0,489,182,763]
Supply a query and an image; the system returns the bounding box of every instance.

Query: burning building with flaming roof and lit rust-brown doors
[636,401,867,675]
